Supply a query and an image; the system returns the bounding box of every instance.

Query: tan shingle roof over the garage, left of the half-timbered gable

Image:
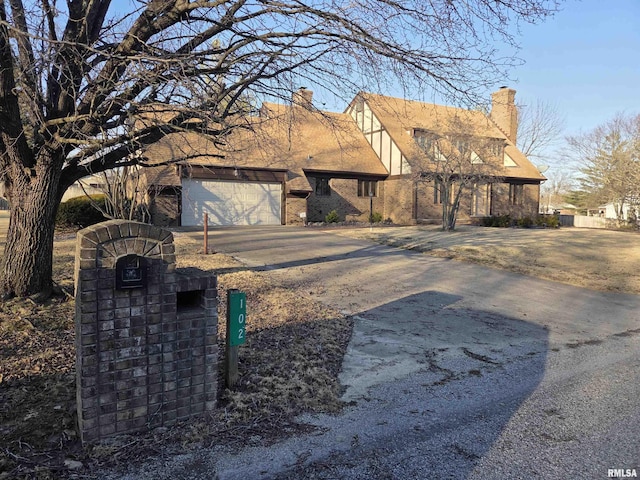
[145,104,388,191]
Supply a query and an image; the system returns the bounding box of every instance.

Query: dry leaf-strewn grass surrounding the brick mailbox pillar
[0,234,352,479]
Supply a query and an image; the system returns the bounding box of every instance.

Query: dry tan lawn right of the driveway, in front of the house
[336,225,640,294]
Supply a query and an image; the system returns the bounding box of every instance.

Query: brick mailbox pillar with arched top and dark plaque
[75,220,218,442]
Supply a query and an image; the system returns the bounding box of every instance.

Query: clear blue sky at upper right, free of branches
[509,0,640,135]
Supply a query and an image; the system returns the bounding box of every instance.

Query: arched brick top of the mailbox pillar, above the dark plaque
[76,220,176,271]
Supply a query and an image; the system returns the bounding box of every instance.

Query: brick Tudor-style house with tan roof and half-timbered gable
[143,88,544,226]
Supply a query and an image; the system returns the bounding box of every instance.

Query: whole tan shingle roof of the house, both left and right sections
[145,93,544,192]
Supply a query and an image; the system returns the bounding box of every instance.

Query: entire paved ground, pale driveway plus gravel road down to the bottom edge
[109,227,640,479]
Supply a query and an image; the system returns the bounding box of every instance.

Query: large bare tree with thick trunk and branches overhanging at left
[0,0,556,296]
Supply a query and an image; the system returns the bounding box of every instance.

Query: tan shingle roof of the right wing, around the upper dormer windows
[360,93,545,181]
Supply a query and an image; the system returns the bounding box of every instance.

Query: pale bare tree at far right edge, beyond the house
[567,114,640,226]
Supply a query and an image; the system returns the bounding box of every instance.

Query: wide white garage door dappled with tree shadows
[182,179,282,226]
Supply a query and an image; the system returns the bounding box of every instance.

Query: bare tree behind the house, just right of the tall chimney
[517,100,566,162]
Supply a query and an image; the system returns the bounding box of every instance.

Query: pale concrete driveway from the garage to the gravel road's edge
[200,227,640,400]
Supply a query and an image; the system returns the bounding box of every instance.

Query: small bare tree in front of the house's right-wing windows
[413,117,504,231]
